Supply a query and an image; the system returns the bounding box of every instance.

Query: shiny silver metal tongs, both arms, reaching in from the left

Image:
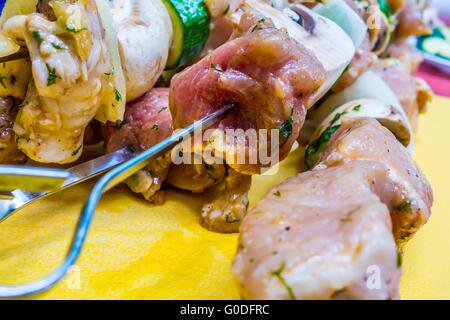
[0,105,233,298]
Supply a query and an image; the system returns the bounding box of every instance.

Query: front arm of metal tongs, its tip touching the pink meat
[0,105,233,298]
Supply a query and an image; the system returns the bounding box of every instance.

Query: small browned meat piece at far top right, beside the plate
[395,0,431,39]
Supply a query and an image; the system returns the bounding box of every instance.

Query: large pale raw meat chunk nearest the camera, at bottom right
[232,161,401,300]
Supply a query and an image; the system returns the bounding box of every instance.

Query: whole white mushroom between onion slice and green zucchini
[109,0,173,101]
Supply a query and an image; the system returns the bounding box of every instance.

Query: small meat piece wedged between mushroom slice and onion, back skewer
[332,35,377,92]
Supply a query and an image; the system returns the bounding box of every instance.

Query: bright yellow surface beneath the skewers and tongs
[0,98,450,299]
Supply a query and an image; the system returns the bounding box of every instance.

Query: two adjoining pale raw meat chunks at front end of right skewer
[233,118,433,299]
